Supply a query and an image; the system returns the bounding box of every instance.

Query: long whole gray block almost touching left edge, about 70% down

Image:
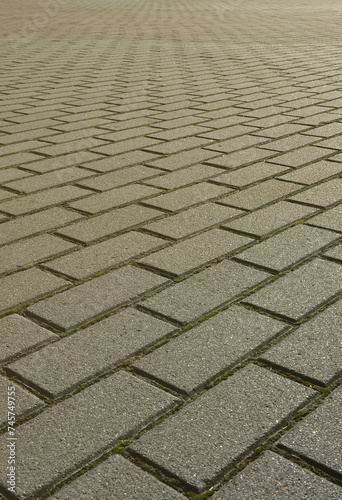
[6,309,176,397]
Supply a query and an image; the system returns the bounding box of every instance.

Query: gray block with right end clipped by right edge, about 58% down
[246,259,342,321]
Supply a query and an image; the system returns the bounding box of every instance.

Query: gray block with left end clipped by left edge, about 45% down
[0,208,82,245]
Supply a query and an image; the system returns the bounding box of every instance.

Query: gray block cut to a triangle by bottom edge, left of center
[50,455,186,500]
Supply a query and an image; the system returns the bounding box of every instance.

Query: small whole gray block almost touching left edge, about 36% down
[5,167,95,193]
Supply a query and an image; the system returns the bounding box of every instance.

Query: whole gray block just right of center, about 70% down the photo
[133,305,286,394]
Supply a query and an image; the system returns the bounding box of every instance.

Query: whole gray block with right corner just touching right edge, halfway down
[238,224,340,271]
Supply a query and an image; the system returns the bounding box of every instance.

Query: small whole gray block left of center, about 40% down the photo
[68,184,161,214]
